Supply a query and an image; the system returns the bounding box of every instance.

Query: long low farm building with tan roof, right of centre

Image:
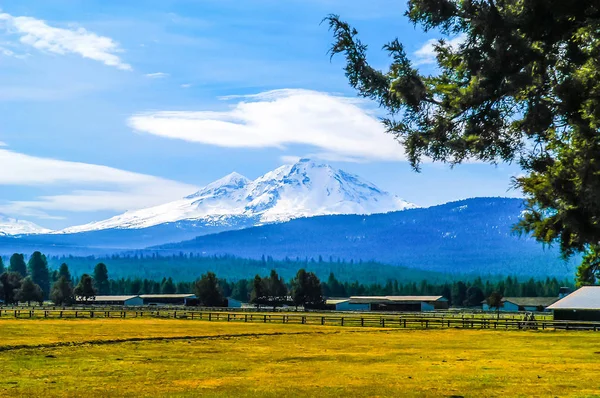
[326,296,448,312]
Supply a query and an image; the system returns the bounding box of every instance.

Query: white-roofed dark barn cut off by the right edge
[548,286,600,321]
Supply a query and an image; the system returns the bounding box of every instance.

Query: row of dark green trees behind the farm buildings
[0,251,573,308]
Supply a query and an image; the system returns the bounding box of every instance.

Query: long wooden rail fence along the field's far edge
[0,309,600,331]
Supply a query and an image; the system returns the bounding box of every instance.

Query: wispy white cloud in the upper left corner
[0,13,132,70]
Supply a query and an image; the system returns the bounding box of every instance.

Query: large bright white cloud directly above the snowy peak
[128,90,406,161]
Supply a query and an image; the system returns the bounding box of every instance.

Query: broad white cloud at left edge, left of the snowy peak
[0,148,197,217]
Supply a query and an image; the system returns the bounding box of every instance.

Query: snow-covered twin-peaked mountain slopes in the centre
[59,159,417,233]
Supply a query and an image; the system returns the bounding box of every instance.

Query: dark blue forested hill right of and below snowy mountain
[157,198,578,278]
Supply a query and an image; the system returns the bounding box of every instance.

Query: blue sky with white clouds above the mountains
[0,0,519,228]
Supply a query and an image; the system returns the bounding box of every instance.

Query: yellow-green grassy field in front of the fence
[0,319,600,397]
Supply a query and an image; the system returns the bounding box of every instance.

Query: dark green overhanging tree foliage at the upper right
[327,0,600,282]
